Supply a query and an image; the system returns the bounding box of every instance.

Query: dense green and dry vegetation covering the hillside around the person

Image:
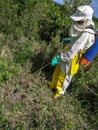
[0,0,98,130]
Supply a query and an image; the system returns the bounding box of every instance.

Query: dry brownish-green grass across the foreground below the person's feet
[0,68,98,130]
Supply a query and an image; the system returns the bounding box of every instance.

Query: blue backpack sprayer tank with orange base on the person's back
[80,34,98,66]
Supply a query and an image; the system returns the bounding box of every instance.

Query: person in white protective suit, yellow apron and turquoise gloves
[49,5,95,99]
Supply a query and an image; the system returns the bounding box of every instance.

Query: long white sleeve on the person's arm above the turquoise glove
[61,33,89,62]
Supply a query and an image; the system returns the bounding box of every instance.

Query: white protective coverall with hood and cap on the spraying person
[60,6,95,94]
